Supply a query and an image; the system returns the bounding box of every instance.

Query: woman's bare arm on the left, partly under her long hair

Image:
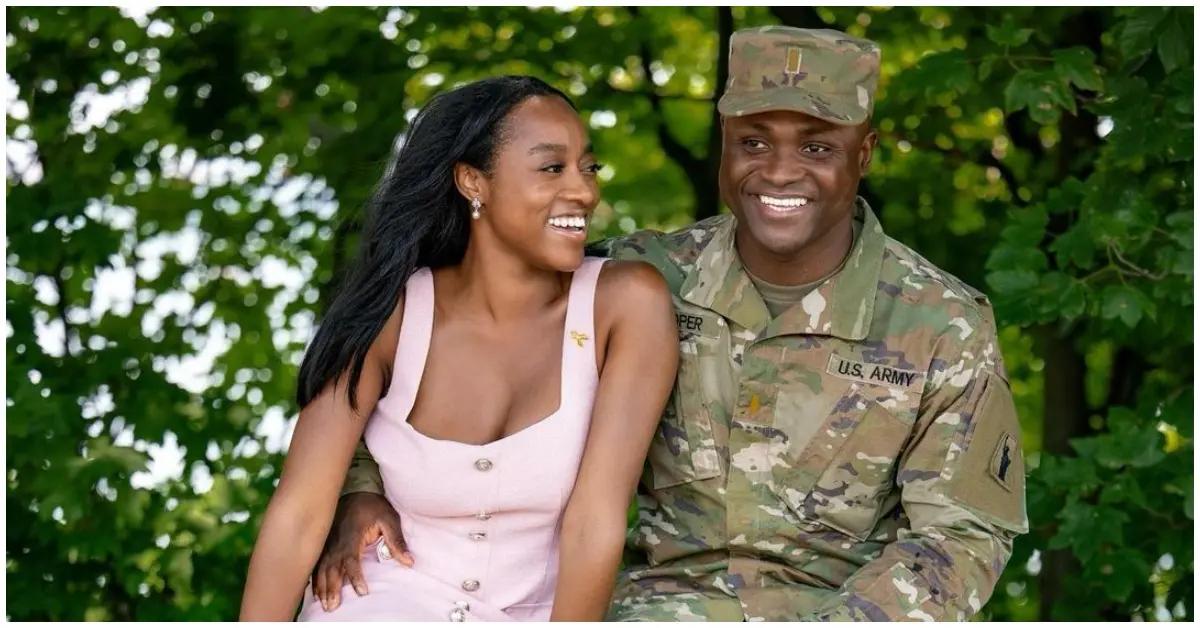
[240,298,402,621]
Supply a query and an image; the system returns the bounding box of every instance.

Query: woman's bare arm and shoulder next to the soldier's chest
[551,262,679,621]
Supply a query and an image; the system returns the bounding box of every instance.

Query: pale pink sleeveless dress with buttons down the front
[299,258,604,621]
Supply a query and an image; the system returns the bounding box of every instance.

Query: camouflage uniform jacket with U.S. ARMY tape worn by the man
[597,199,1027,621]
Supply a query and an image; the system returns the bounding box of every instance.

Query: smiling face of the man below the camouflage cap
[720,110,875,258]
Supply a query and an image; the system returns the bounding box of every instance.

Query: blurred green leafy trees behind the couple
[5,6,1195,621]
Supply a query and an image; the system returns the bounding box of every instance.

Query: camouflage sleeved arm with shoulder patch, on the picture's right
[803,321,1028,621]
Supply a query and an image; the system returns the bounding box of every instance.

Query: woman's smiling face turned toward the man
[470,96,600,271]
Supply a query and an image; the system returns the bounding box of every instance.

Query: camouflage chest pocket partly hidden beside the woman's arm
[647,334,721,490]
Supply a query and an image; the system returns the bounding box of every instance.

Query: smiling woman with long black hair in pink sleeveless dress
[241,77,678,621]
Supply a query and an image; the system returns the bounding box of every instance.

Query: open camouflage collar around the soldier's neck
[679,197,884,341]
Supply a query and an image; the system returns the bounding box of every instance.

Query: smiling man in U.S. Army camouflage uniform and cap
[307,26,1027,621]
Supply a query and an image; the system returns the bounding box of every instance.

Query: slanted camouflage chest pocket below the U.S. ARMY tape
[773,401,912,540]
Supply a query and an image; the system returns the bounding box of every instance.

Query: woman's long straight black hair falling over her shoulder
[296,76,574,411]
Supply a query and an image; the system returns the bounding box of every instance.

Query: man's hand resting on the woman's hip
[312,492,413,612]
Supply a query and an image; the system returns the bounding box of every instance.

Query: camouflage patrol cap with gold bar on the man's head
[716,26,880,125]
